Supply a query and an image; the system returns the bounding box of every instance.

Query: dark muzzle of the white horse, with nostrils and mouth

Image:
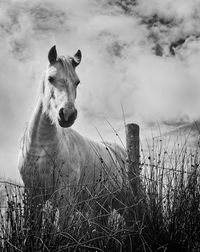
[58,108,77,128]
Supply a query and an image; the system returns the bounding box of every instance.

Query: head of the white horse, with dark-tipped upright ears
[42,46,81,128]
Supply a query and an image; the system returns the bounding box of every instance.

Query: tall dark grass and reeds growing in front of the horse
[0,131,200,252]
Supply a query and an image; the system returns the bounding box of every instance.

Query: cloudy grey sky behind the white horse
[0,0,200,179]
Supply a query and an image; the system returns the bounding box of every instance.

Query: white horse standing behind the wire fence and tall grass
[19,46,126,207]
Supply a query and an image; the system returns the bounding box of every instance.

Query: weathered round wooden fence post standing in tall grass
[126,123,140,198]
